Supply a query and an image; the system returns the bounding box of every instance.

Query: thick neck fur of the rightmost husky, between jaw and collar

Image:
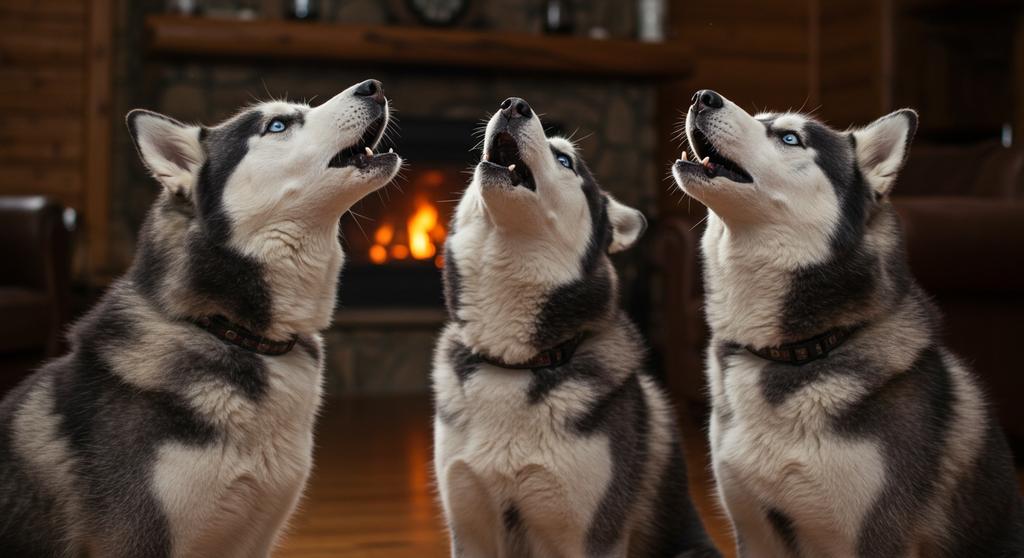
[701,201,912,347]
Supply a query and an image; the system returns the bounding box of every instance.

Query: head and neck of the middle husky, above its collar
[444,97,646,362]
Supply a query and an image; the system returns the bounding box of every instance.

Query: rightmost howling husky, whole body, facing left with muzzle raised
[673,90,1024,558]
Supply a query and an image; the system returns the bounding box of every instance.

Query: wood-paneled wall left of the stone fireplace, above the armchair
[0,0,113,271]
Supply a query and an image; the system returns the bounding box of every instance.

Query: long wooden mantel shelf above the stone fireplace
[146,15,692,79]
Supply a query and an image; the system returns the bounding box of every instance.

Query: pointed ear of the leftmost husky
[126,109,205,196]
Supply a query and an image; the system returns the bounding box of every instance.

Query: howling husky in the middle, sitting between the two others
[433,97,717,558]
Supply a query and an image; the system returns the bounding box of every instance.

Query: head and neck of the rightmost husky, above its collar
[673,90,918,346]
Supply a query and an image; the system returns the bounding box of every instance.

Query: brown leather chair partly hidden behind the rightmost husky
[656,143,1024,457]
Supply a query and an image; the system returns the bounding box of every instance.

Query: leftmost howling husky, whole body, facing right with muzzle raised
[0,80,400,558]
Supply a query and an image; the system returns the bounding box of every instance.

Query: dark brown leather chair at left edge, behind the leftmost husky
[0,197,75,391]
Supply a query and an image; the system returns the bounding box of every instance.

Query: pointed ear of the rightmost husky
[853,109,918,198]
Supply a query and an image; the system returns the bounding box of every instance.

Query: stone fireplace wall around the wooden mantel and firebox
[112,0,665,393]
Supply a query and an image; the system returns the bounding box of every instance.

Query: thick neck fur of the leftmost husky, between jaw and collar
[128,191,343,340]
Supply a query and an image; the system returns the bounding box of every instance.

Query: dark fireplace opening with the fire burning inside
[339,119,560,308]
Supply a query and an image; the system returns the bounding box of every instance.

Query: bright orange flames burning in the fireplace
[370,199,445,267]
